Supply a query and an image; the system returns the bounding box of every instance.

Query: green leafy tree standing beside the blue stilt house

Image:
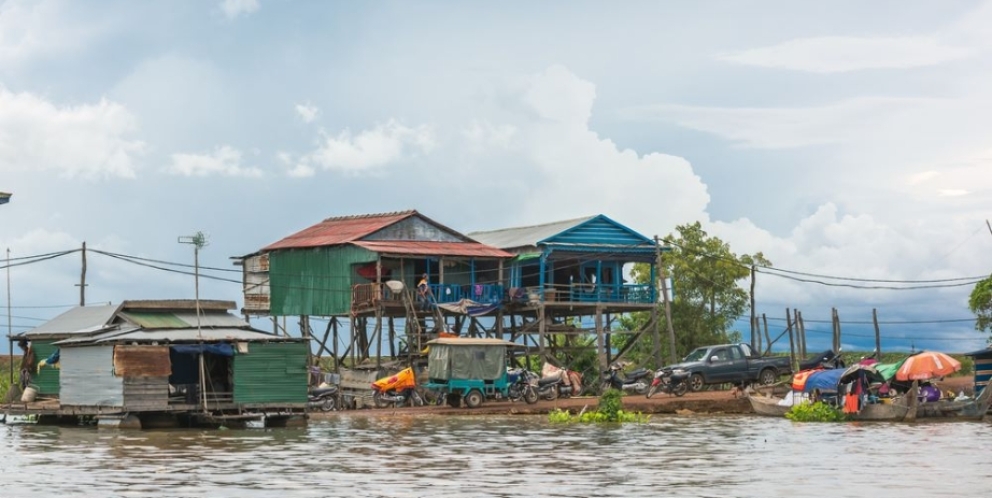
[614,221,771,363]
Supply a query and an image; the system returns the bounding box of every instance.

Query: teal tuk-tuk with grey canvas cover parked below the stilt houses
[424,337,520,408]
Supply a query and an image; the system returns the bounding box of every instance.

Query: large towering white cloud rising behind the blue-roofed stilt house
[439,66,709,235]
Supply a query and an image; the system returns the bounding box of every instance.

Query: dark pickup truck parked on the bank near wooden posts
[671,344,792,391]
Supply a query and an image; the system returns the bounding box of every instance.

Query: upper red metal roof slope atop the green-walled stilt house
[262,210,417,251]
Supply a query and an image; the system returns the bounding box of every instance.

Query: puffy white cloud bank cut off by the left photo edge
[0,87,145,178]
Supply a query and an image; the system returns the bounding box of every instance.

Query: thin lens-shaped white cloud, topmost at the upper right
[717,36,977,73]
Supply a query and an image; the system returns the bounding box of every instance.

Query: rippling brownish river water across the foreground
[0,412,992,498]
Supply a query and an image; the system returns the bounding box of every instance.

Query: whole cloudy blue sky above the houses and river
[0,0,992,352]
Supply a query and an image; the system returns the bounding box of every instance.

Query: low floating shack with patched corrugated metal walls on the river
[8,300,309,425]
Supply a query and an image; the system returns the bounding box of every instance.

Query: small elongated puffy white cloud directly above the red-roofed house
[297,119,435,173]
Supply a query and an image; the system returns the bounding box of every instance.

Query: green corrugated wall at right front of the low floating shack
[234,342,309,403]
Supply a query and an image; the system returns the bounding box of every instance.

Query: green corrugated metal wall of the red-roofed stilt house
[269,246,376,316]
